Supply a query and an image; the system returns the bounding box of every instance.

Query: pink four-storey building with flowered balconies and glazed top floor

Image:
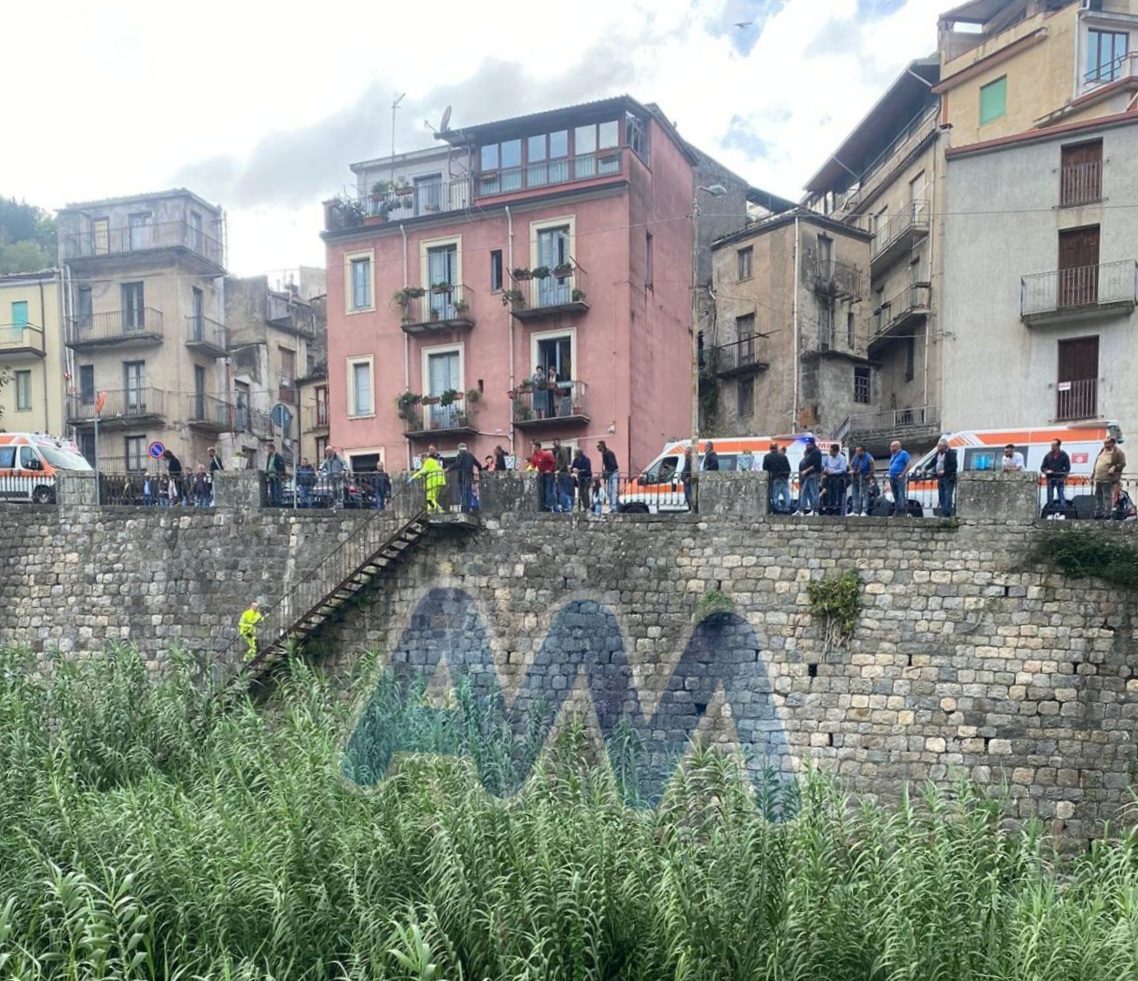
[323,97,745,470]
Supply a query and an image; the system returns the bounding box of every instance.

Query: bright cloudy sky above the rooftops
[0,0,955,275]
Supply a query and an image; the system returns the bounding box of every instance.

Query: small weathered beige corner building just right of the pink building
[700,209,879,437]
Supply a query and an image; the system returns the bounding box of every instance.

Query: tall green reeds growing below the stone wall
[0,651,1138,981]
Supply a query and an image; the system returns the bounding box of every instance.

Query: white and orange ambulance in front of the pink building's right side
[617,432,831,514]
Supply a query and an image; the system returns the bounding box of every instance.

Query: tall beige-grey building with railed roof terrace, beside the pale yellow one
[58,189,228,471]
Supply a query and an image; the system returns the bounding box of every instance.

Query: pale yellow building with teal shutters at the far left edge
[0,269,66,436]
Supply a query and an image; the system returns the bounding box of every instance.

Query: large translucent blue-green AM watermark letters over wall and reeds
[343,588,792,805]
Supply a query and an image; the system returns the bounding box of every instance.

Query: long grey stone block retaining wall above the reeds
[0,475,1138,838]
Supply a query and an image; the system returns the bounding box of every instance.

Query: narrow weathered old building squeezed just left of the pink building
[221,275,327,467]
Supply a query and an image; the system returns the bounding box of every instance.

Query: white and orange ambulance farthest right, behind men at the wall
[892,422,1122,517]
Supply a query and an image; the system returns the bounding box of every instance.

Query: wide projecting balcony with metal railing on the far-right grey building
[1020,258,1138,327]
